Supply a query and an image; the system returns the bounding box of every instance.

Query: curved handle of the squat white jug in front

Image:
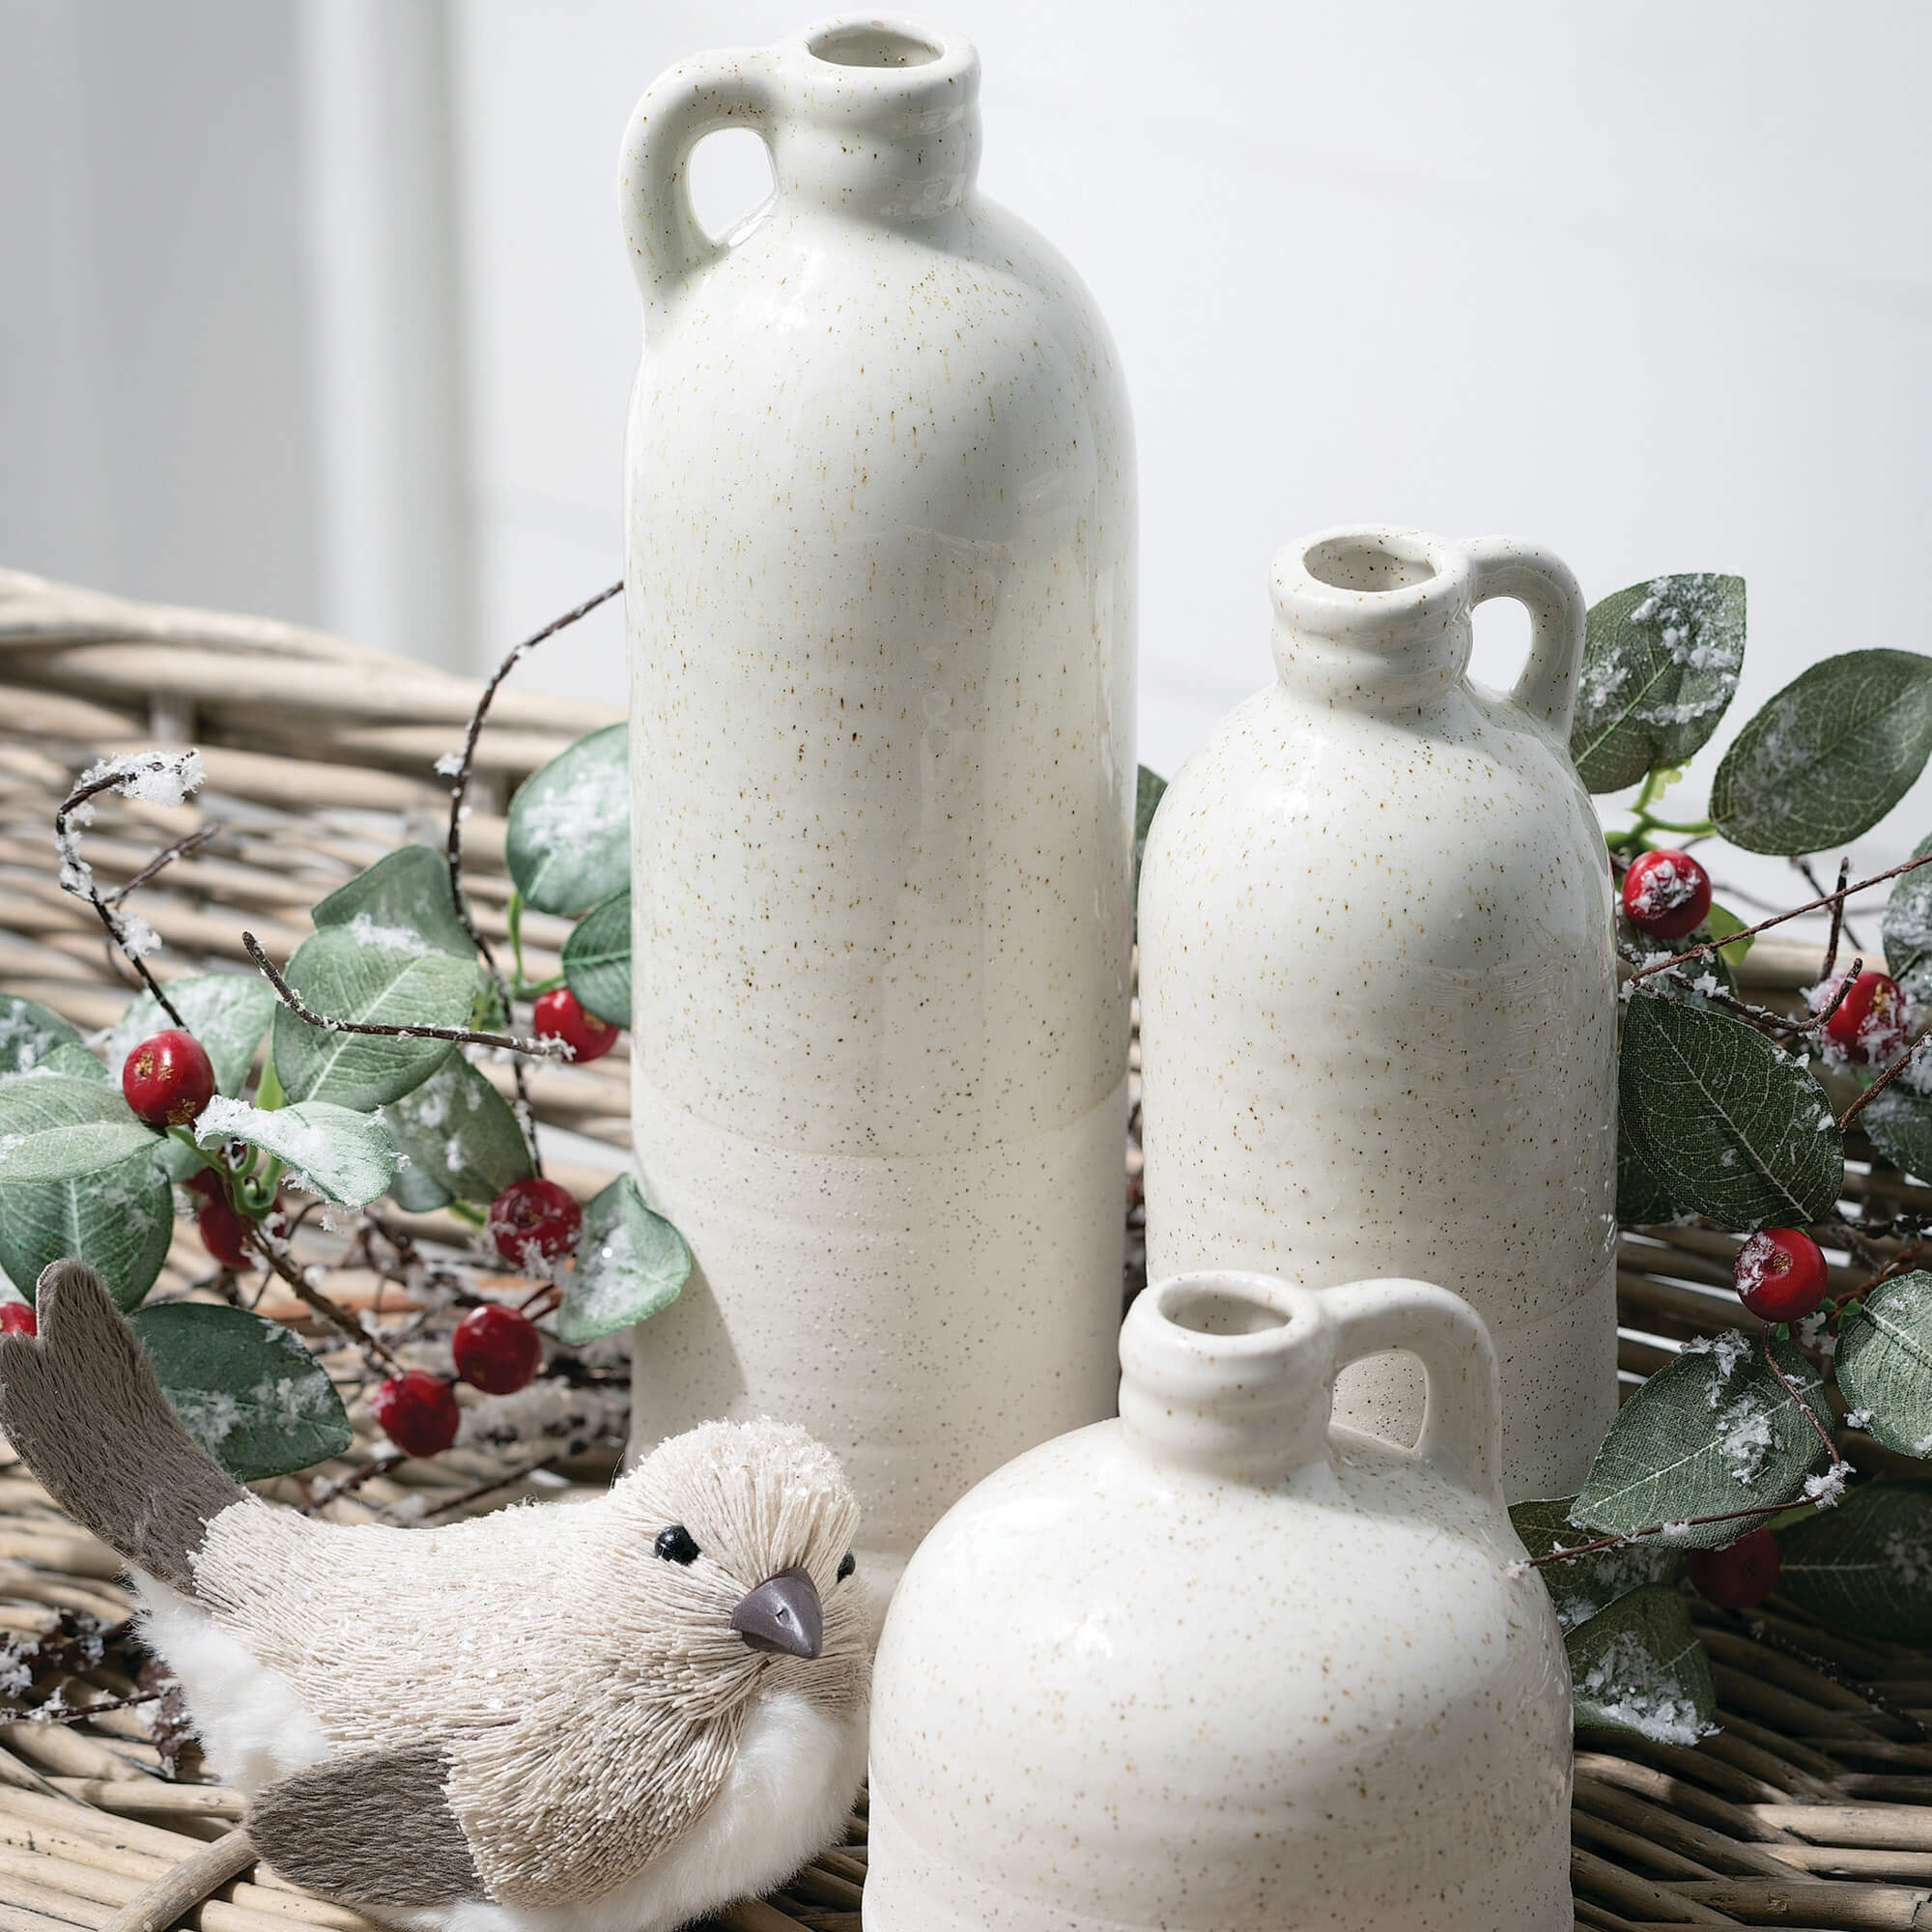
[1320,1279,1503,1509]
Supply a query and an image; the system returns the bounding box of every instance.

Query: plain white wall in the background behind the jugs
[0,0,1932,920]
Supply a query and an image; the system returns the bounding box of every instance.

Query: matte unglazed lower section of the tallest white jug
[632,1078,1126,1569]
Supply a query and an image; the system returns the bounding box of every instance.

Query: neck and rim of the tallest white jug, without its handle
[771,14,980,220]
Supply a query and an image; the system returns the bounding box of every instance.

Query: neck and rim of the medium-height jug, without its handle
[1271,524,1474,711]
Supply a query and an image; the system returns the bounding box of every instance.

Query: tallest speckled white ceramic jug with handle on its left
[622,17,1134,1580]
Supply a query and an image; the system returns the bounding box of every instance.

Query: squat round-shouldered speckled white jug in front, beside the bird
[866,1273,1573,1932]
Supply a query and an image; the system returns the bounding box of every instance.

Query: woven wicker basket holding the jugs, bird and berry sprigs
[0,572,1932,1932]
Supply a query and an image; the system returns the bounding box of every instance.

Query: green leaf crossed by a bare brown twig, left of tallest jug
[274,925,481,1107]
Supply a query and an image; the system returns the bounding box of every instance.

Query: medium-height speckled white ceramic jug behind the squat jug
[1140,526,1617,1499]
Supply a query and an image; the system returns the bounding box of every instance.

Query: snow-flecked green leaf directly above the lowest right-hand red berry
[1571,1331,1830,1549]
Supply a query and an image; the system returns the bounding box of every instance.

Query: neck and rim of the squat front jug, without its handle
[1121,1269,1335,1482]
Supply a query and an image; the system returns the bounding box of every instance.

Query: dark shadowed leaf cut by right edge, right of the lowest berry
[1777,1478,1932,1644]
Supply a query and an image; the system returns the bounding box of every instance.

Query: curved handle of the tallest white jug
[618,48,779,305]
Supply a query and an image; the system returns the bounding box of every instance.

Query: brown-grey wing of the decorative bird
[243,1741,483,1907]
